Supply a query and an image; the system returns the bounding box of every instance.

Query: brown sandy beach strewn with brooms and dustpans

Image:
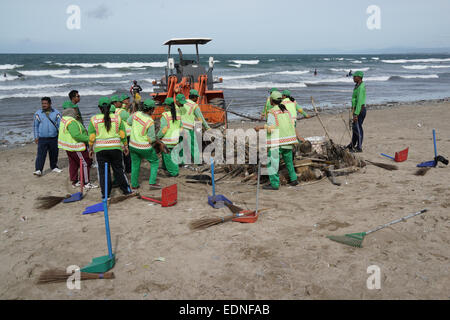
[0,101,450,300]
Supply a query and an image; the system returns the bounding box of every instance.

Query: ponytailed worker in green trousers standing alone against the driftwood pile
[255,91,298,190]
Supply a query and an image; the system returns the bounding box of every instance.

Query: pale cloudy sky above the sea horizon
[0,0,450,54]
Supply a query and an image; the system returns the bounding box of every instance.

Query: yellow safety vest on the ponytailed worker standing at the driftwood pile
[267,106,298,148]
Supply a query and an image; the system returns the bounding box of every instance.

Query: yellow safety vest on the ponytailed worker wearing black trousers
[91,114,121,152]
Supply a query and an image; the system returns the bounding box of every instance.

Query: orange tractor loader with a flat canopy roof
[150,38,227,127]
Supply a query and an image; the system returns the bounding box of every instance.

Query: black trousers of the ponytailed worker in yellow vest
[96,149,131,198]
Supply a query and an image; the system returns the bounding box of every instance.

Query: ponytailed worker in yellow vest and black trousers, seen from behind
[88,97,132,198]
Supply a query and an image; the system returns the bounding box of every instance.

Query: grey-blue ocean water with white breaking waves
[0,54,450,143]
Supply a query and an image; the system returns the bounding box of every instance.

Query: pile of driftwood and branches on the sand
[186,139,366,185]
